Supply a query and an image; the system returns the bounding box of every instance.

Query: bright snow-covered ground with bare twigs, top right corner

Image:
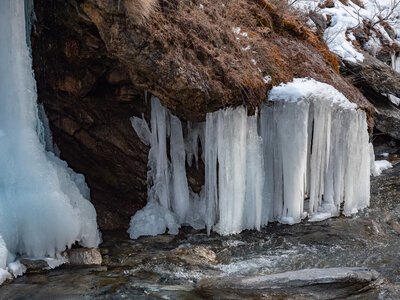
[292,0,400,63]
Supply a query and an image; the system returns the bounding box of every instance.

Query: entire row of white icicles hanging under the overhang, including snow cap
[129,79,371,238]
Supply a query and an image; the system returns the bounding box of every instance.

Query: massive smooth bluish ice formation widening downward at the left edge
[0,0,100,282]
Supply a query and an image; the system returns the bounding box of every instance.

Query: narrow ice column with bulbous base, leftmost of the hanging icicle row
[128,97,190,238]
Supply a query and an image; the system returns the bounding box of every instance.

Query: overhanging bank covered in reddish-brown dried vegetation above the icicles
[76,0,372,120]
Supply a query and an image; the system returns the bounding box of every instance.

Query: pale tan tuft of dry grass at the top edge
[122,0,158,25]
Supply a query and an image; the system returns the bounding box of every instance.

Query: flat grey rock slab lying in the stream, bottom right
[197,268,383,299]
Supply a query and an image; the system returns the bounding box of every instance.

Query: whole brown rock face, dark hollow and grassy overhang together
[32,0,372,229]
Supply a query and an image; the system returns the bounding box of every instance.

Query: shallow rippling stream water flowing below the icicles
[0,157,400,299]
